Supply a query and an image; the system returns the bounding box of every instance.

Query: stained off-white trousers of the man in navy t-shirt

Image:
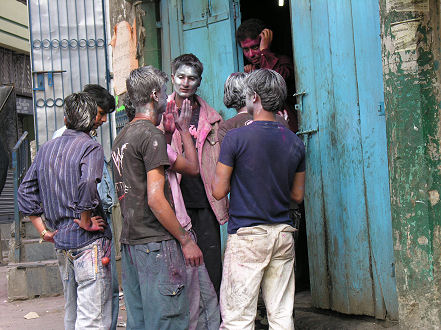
[220,224,295,330]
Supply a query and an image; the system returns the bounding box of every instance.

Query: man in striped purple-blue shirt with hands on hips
[18,93,112,330]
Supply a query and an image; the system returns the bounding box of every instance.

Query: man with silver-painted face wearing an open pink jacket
[168,54,228,293]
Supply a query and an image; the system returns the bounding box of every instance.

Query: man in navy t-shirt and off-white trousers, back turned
[213,69,305,329]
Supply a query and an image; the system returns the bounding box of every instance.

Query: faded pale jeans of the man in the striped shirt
[57,238,112,330]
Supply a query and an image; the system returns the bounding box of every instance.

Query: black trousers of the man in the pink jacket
[187,207,222,299]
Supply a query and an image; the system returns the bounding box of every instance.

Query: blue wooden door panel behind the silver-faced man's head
[161,0,243,119]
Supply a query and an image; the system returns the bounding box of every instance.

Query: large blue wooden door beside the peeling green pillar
[291,0,398,319]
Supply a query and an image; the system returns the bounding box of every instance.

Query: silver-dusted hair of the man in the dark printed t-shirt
[126,65,168,108]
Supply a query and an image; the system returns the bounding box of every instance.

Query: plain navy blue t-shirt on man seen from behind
[219,121,305,234]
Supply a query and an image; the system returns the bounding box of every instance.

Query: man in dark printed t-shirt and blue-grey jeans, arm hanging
[112,66,203,329]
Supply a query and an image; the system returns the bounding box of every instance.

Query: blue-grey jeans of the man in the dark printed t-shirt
[121,240,189,330]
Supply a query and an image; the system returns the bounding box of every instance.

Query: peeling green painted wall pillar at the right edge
[380,0,441,329]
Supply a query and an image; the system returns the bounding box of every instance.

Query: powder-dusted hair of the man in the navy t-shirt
[245,69,287,112]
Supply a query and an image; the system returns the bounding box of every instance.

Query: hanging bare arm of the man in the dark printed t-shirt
[147,166,203,266]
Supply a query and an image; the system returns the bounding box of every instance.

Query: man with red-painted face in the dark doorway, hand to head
[236,18,298,132]
